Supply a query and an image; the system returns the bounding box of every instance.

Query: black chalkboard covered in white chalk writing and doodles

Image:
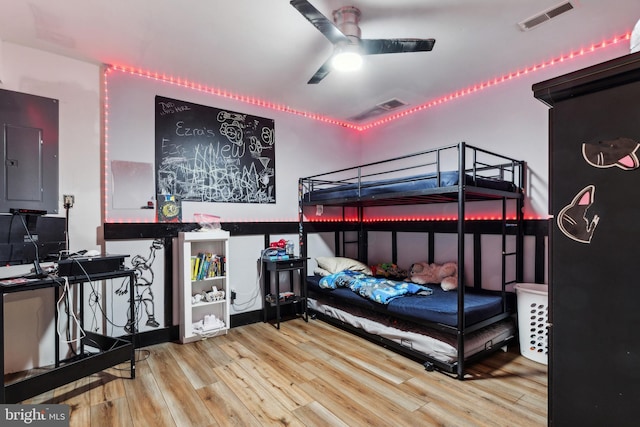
[155,96,276,203]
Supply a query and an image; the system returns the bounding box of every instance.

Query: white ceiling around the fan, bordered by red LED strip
[0,0,640,120]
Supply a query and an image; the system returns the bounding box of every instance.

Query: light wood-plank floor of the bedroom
[13,319,547,427]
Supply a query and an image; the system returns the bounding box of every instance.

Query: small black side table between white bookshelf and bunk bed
[262,257,309,329]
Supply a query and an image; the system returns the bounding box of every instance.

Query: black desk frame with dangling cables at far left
[0,270,136,404]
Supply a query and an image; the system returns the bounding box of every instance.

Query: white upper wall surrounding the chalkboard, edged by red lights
[107,70,360,222]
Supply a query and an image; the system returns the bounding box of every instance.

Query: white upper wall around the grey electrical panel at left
[0,42,102,250]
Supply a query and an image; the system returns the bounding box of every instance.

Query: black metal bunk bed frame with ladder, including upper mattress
[299,142,525,379]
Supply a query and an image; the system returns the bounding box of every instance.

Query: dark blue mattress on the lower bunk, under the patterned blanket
[307,275,502,327]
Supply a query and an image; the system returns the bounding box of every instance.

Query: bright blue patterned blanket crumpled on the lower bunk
[319,270,433,304]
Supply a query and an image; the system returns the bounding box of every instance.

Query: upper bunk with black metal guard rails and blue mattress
[300,143,525,206]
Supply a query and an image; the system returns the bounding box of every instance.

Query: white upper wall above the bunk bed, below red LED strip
[362,43,629,218]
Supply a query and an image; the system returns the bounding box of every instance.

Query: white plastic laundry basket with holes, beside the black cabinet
[515,283,549,365]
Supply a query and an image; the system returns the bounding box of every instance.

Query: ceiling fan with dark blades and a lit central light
[290,0,436,84]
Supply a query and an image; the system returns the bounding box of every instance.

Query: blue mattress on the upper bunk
[304,171,516,202]
